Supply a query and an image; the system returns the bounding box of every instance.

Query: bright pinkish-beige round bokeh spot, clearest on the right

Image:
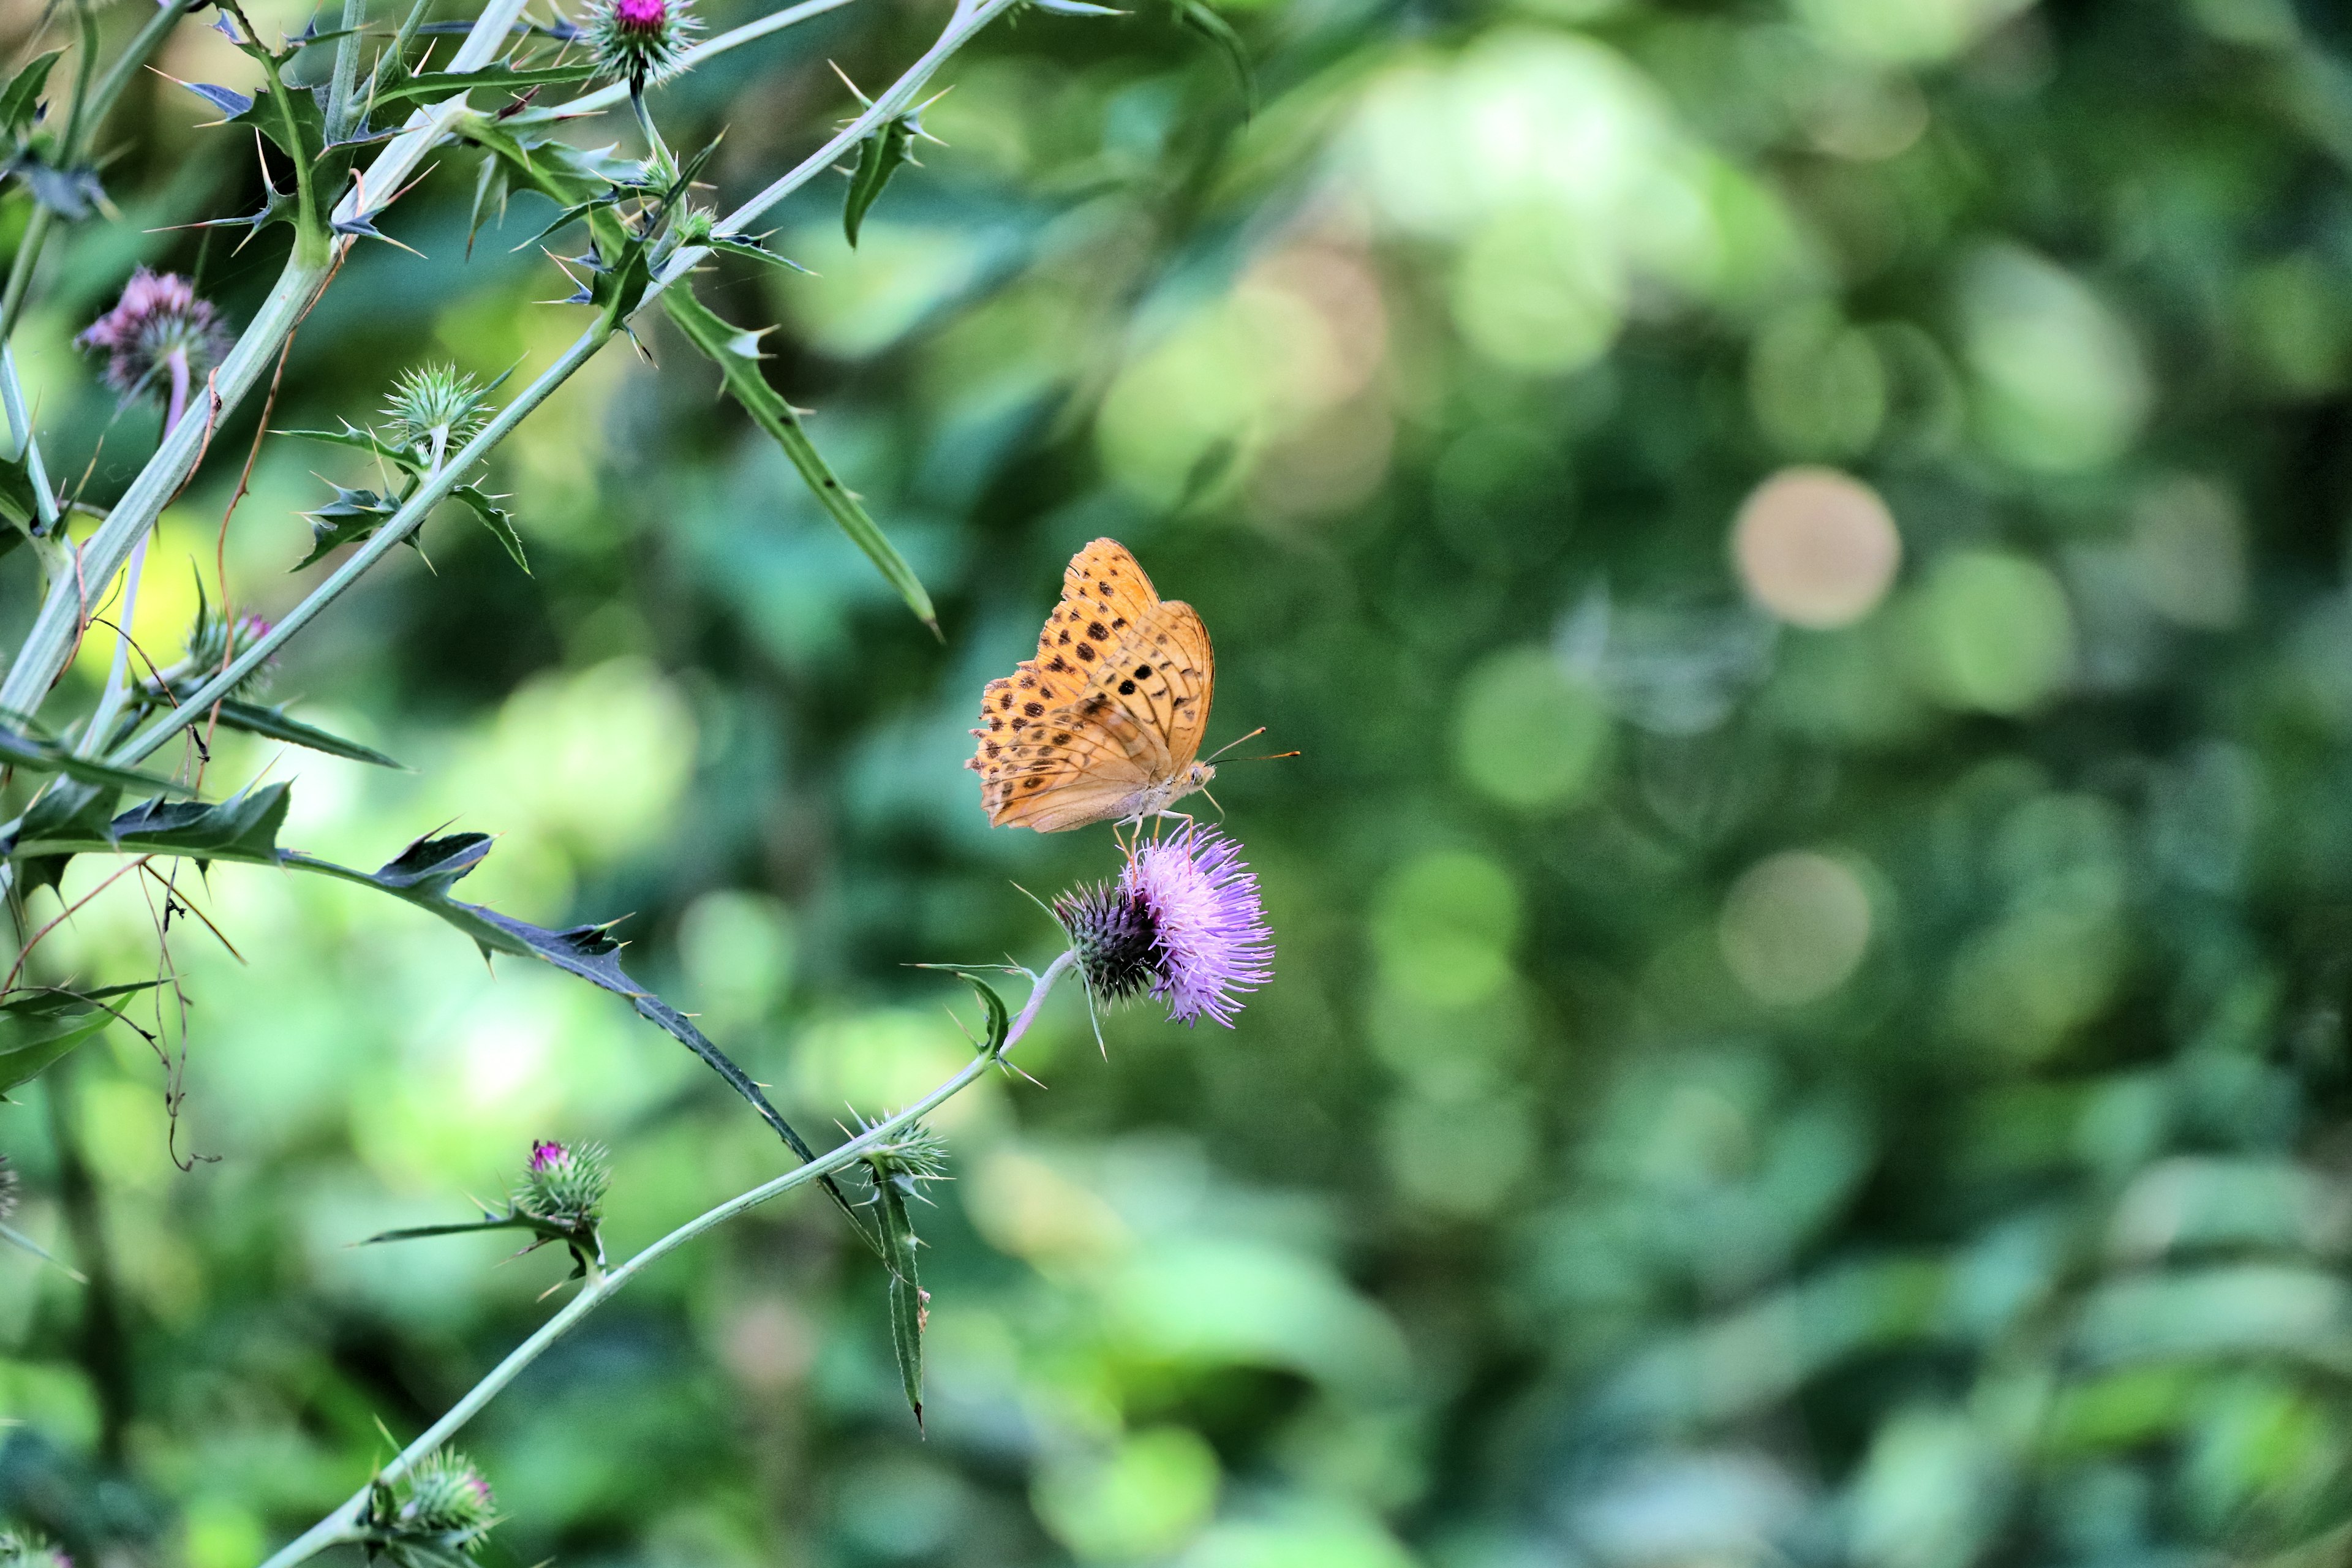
[1731,468,1903,630]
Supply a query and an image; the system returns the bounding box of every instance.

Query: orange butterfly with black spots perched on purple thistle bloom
[964,538,1216,832]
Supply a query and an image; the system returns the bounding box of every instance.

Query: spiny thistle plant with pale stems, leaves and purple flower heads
[0,0,1270,1568]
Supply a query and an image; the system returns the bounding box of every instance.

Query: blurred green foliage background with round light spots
[13,0,2352,1568]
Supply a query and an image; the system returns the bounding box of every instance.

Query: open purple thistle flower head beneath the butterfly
[1054,823,1275,1027]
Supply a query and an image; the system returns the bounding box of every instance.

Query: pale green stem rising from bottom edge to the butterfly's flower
[248,950,1077,1568]
